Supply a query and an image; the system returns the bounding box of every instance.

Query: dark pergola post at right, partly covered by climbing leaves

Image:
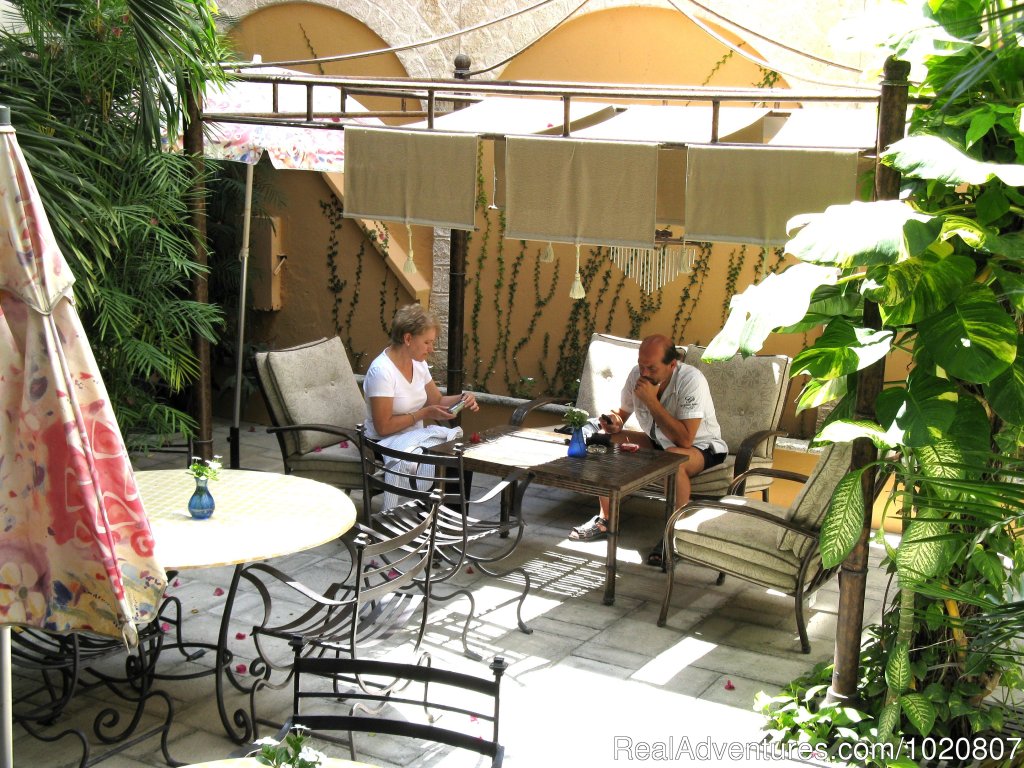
[828,57,910,701]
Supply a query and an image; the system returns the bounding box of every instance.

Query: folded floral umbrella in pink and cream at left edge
[0,108,165,647]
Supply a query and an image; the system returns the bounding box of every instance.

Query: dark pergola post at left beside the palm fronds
[183,88,213,459]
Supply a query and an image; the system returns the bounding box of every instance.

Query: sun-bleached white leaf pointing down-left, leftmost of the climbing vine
[703,264,839,360]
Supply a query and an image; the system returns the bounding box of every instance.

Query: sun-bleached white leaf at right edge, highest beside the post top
[882,135,1024,186]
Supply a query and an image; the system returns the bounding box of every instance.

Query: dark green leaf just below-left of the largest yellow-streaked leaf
[876,369,957,446]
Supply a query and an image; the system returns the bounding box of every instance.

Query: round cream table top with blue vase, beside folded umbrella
[135,469,355,573]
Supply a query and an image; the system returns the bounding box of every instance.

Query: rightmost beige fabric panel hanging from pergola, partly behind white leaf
[685,144,858,246]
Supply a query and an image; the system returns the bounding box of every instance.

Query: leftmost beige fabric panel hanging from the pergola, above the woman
[345,127,479,229]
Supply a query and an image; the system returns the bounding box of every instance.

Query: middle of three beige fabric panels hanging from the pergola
[505,137,657,248]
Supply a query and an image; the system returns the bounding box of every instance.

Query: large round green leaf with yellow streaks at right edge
[918,284,1017,384]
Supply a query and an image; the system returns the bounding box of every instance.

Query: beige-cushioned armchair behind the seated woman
[256,336,366,490]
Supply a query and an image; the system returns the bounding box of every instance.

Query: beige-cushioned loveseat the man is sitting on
[511,334,792,501]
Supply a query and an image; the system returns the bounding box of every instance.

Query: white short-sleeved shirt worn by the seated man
[622,362,729,454]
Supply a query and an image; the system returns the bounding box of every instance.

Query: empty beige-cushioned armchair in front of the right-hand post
[657,442,852,653]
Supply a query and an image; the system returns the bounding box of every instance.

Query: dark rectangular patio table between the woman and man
[430,425,687,605]
